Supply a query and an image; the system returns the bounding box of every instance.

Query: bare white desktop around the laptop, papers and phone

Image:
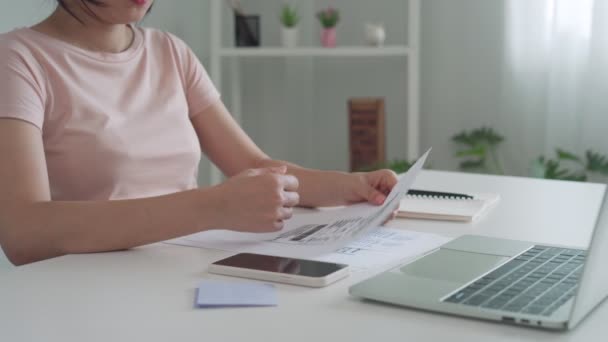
[0,171,608,342]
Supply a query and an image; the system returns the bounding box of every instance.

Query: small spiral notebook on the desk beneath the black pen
[397,193,500,222]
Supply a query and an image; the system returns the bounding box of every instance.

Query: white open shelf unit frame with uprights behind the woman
[209,0,420,185]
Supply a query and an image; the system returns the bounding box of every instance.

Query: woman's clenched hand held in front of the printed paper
[210,166,300,233]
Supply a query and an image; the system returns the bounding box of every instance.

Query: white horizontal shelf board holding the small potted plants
[219,45,410,57]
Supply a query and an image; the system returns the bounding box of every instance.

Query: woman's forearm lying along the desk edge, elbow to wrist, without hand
[0,188,218,264]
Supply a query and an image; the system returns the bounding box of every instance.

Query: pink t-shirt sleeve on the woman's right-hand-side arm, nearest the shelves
[169,34,220,117]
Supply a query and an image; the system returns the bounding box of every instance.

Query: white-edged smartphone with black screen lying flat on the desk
[208,253,350,287]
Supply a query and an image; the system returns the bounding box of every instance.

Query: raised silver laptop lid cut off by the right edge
[568,188,608,328]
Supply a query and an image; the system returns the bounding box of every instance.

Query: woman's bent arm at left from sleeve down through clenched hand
[0,119,298,265]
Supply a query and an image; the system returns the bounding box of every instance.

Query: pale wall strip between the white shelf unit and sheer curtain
[421,0,512,169]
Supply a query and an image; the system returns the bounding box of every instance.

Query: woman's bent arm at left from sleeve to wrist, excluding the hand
[0,119,213,264]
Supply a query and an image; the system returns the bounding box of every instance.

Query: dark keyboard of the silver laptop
[444,246,586,316]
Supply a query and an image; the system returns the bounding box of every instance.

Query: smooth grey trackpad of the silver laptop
[401,249,509,283]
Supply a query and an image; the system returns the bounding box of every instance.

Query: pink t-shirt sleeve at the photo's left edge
[0,39,45,129]
